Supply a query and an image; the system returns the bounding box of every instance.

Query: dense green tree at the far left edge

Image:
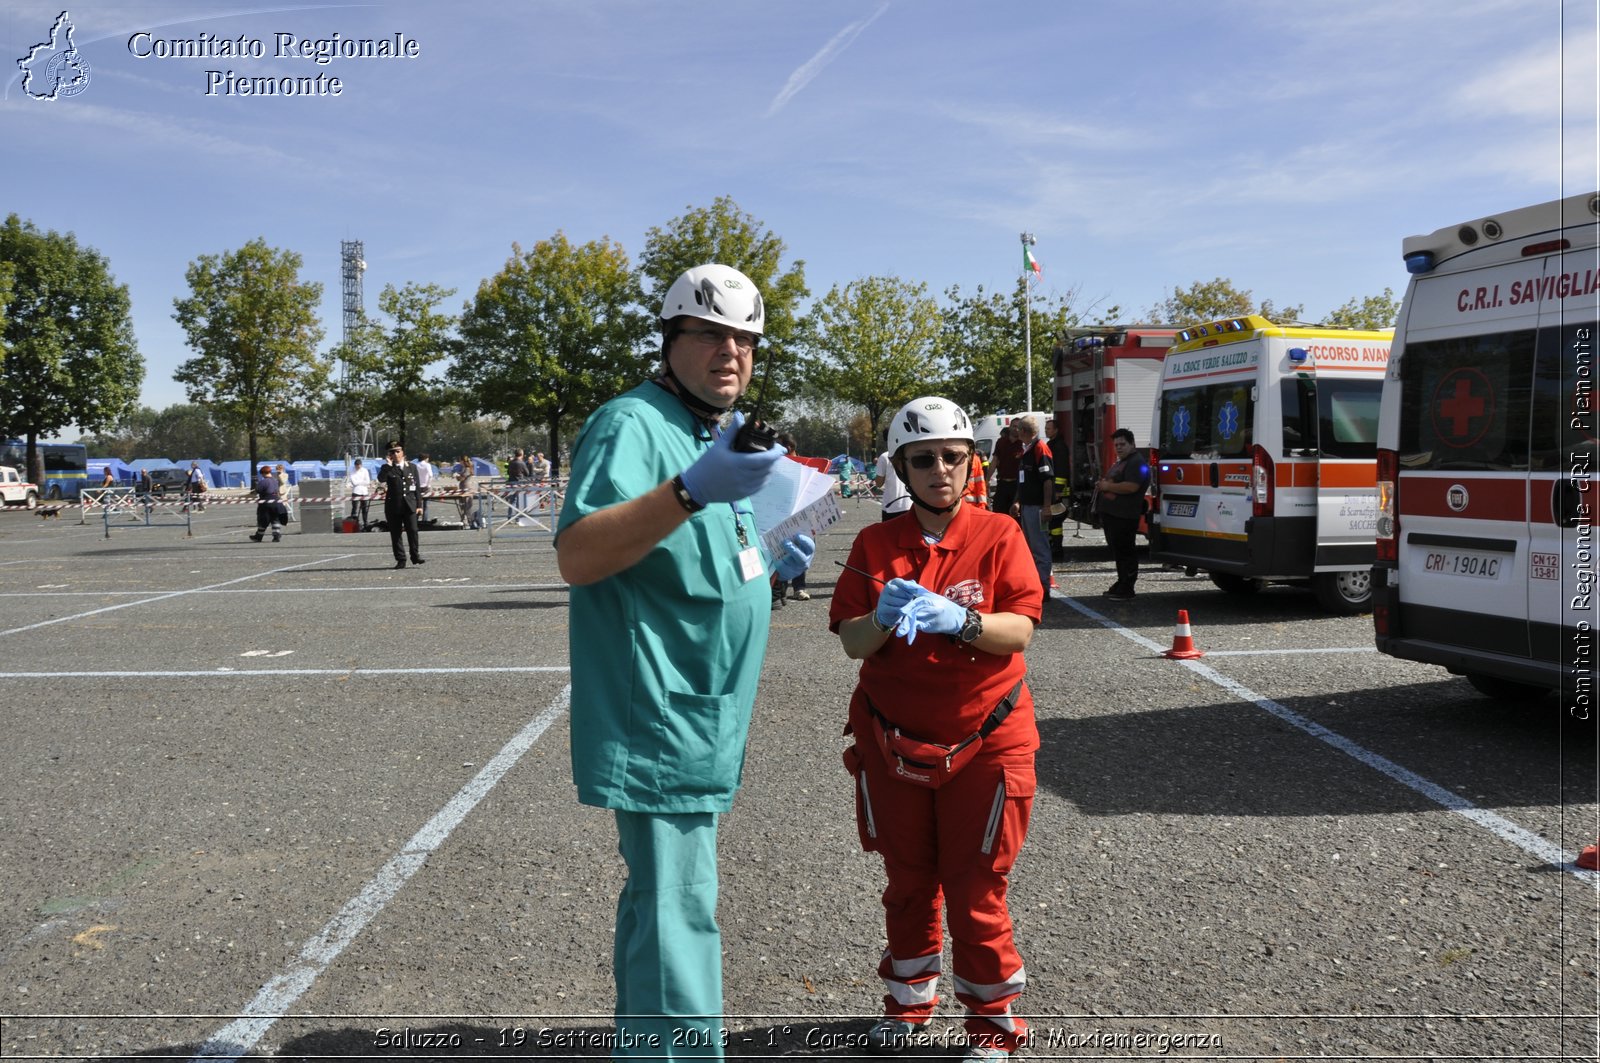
[0,215,144,482]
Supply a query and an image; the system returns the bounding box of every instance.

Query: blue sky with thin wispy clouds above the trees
[0,0,1600,407]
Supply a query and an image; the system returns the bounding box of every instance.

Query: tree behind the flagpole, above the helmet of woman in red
[939,279,1078,429]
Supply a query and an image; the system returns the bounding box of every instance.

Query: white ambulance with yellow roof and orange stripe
[1147,315,1392,613]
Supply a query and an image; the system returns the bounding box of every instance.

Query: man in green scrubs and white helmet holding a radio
[555,264,810,1058]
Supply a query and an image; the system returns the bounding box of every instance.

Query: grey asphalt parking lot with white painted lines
[0,501,1600,1060]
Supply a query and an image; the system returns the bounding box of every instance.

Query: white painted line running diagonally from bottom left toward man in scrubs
[194,685,573,1063]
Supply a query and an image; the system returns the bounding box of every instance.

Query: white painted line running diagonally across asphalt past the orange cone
[1051,591,1600,889]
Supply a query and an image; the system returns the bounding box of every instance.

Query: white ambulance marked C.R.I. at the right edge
[1373,192,1600,719]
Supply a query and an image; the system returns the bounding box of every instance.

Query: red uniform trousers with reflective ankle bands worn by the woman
[845,723,1034,1052]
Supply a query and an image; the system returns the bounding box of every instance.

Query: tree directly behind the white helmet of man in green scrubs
[638,195,811,421]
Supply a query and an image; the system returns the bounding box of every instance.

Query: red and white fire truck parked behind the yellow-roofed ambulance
[1054,325,1178,525]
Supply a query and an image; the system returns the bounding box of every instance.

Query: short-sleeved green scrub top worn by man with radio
[555,383,771,813]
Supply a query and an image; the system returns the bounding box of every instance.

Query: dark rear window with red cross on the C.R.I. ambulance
[1400,328,1534,471]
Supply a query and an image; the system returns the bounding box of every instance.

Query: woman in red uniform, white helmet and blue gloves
[829,397,1043,1060]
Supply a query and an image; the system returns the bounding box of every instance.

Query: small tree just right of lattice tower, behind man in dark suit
[344,282,461,450]
